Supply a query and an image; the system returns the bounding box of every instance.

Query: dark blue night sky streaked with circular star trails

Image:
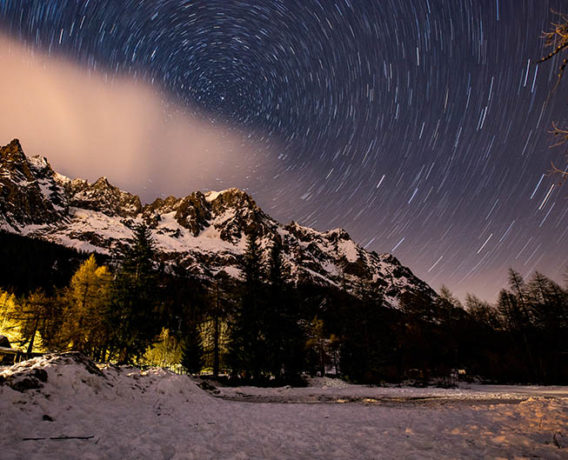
[0,0,568,300]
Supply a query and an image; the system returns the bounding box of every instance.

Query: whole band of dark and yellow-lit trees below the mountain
[0,226,568,384]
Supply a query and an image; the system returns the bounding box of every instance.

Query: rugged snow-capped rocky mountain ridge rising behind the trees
[0,139,436,307]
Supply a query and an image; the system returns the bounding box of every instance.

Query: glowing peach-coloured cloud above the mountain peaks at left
[0,36,270,199]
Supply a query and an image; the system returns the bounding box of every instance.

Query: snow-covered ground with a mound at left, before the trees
[0,354,568,460]
